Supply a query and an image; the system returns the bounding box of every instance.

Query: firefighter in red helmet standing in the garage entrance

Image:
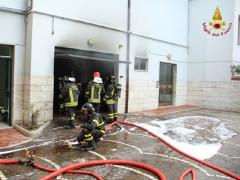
[85,72,105,113]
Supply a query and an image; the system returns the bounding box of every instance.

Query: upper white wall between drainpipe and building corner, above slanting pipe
[131,0,188,45]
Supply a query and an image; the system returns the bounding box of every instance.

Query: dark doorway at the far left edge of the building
[0,45,13,126]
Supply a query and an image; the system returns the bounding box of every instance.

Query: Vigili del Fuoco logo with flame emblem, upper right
[203,6,232,37]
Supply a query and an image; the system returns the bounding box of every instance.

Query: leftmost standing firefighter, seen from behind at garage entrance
[59,76,80,129]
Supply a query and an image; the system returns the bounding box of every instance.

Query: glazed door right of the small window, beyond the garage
[158,62,176,107]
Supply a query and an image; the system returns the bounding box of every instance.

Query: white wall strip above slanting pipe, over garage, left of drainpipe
[33,0,127,30]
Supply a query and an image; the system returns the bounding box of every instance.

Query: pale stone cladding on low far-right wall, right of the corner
[187,81,240,112]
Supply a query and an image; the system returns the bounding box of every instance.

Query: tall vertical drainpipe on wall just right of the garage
[125,0,131,113]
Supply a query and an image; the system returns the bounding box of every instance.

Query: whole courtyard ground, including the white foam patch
[0,106,240,180]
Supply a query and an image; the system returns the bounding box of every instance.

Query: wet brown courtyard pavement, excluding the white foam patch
[0,109,240,180]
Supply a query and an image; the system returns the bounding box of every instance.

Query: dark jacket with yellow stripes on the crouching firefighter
[81,112,105,134]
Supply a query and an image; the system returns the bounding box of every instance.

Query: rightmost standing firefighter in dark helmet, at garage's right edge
[103,75,121,123]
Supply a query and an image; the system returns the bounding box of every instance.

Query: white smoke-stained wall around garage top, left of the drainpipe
[25,0,130,75]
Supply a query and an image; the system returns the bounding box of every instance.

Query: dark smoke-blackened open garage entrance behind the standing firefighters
[53,47,119,116]
